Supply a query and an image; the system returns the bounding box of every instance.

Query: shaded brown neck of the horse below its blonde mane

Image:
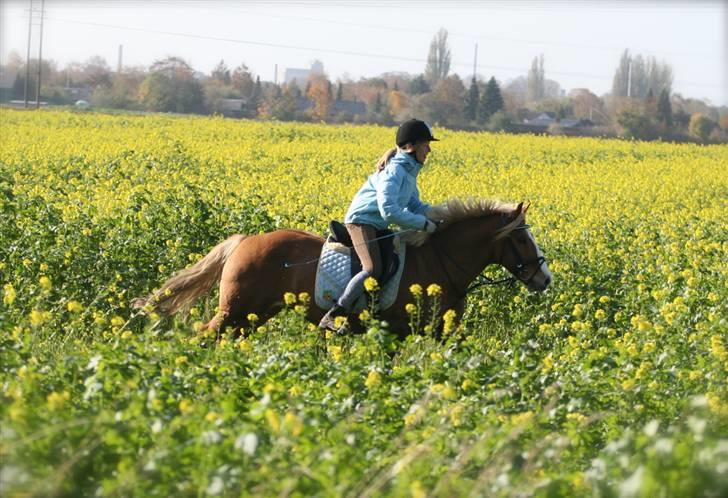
[434,214,501,288]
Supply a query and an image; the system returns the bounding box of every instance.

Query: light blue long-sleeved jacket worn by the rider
[344,152,430,230]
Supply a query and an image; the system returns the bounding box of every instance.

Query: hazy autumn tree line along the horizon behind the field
[2,29,728,141]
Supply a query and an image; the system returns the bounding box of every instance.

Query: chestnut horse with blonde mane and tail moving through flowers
[134,200,551,336]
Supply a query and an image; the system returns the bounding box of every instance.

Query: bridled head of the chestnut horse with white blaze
[494,202,552,291]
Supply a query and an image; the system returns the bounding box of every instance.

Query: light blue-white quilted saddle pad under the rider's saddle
[315,237,406,313]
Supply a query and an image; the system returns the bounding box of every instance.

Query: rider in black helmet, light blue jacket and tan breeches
[319,119,438,330]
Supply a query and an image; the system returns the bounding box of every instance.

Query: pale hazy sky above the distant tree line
[0,0,728,105]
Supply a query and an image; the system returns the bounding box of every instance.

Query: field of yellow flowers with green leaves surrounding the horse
[0,109,728,497]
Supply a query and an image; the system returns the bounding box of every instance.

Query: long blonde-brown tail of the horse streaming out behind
[132,235,247,316]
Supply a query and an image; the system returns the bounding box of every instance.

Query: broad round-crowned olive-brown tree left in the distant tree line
[139,57,204,113]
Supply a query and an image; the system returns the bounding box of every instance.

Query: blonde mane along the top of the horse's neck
[401,199,525,246]
